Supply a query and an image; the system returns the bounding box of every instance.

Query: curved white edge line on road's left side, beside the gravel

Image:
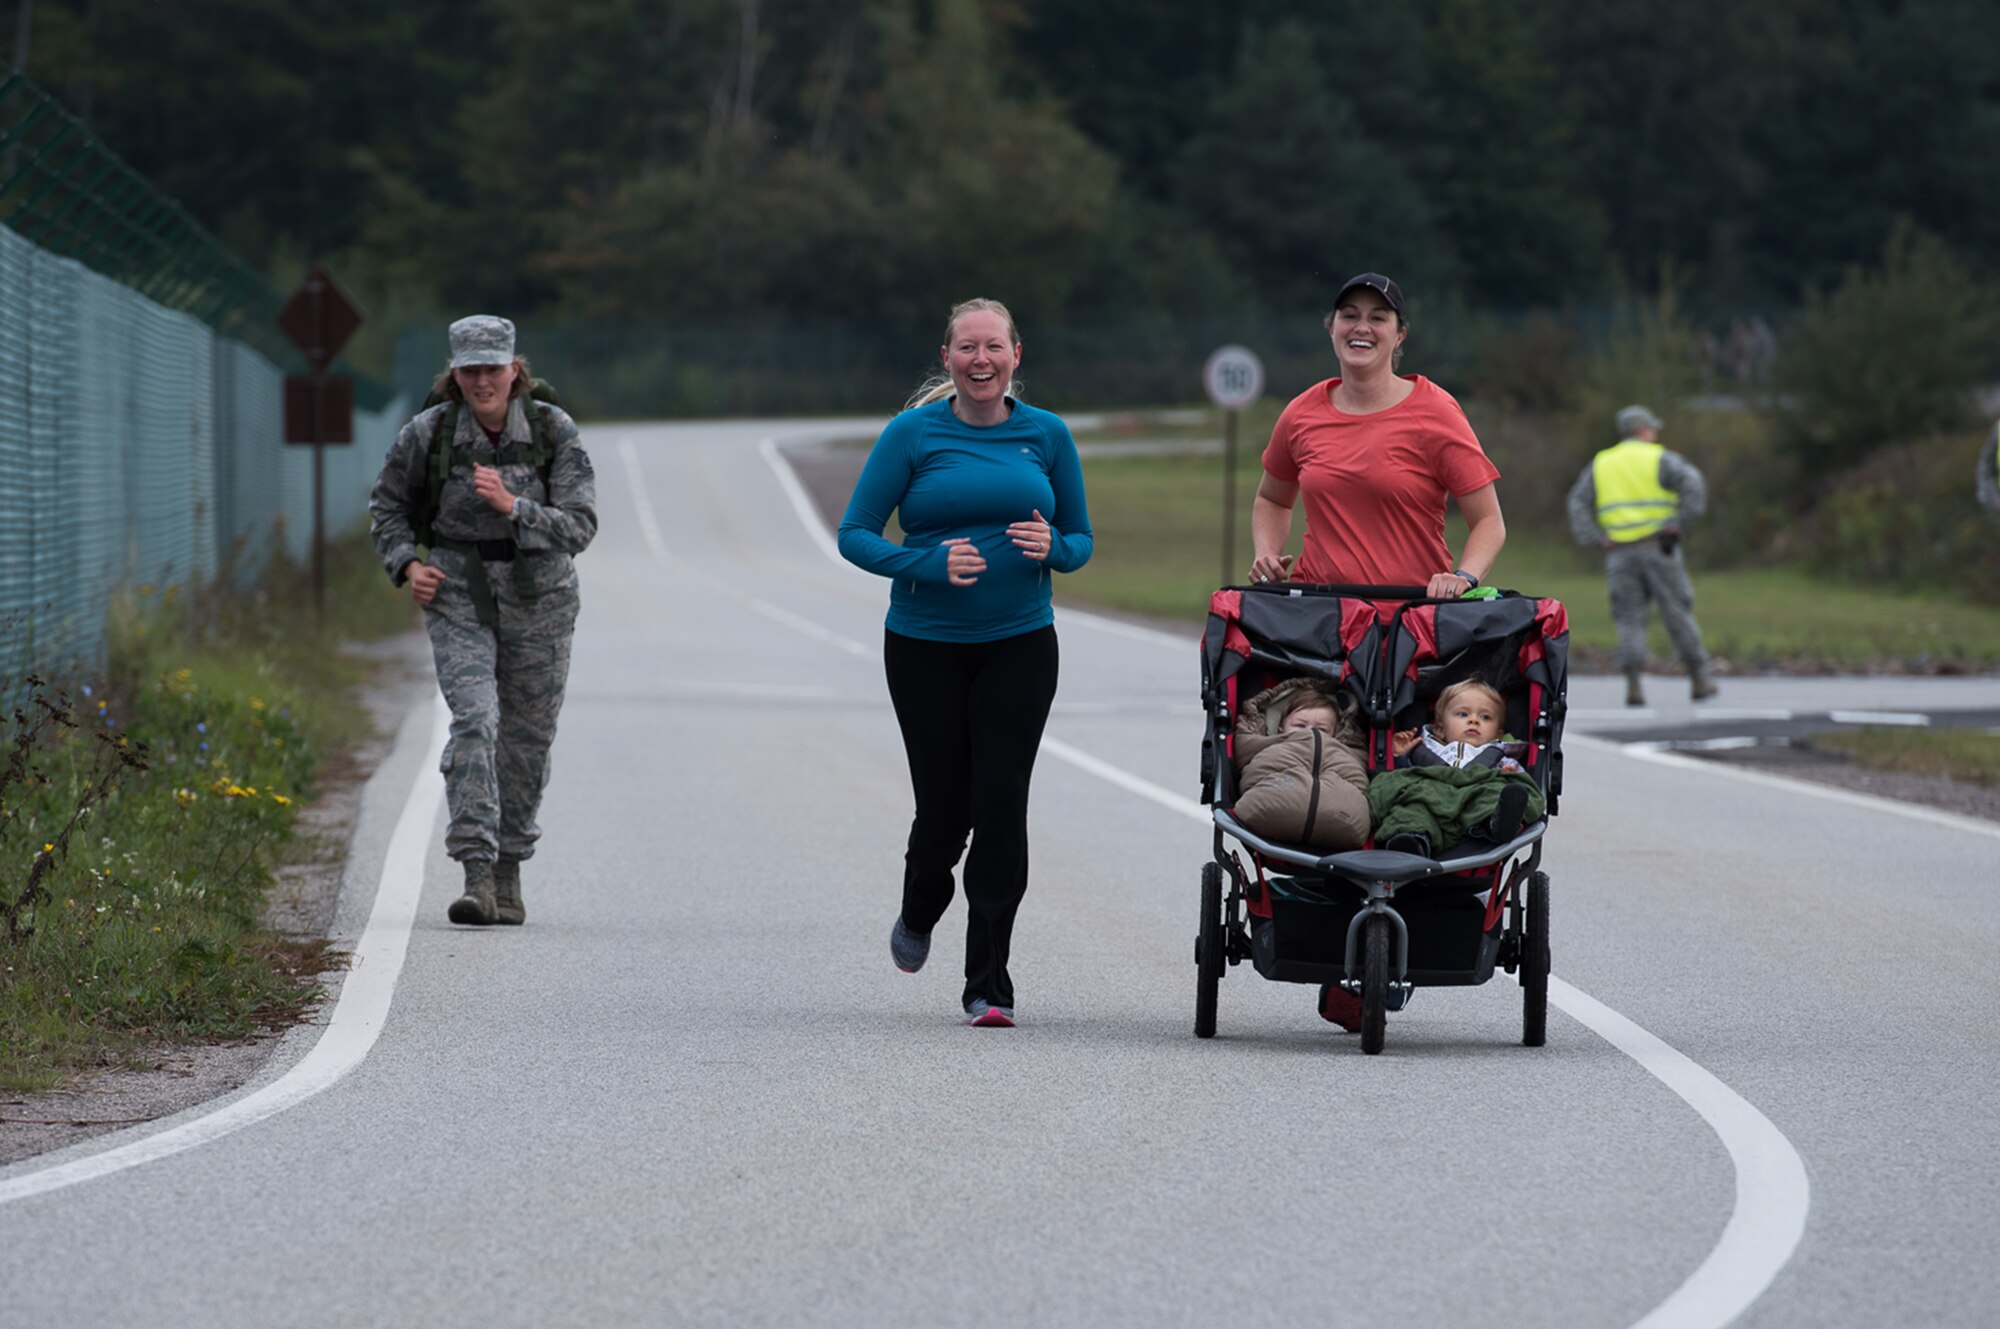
[0,697,452,1205]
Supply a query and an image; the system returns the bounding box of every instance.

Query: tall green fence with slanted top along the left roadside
[0,66,402,671]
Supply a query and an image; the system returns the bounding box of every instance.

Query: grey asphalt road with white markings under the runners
[0,422,2000,1329]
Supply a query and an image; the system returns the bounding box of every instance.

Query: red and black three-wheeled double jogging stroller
[1194,584,1570,1053]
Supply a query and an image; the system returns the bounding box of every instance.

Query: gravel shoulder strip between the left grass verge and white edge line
[0,630,436,1165]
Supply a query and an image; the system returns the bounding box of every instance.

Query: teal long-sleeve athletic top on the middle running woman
[840,398,1092,642]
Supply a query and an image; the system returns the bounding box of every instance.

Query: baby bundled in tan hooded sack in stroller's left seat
[1236,677,1368,849]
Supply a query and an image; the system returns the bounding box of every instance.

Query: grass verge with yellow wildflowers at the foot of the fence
[0,532,412,1091]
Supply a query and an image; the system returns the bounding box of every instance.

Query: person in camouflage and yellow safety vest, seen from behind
[1568,406,1716,707]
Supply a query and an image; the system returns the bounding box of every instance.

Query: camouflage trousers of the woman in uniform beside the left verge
[424,552,578,861]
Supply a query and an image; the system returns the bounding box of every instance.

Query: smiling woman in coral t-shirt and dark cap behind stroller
[1250,272,1506,596]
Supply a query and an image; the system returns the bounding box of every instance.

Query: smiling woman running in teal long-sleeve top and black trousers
[840,300,1092,1027]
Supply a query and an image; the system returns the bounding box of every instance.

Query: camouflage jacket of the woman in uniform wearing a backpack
[368,396,598,586]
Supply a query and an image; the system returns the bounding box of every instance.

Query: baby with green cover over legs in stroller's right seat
[1366,679,1548,859]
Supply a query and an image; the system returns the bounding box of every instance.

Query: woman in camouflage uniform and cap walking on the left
[368,314,598,925]
